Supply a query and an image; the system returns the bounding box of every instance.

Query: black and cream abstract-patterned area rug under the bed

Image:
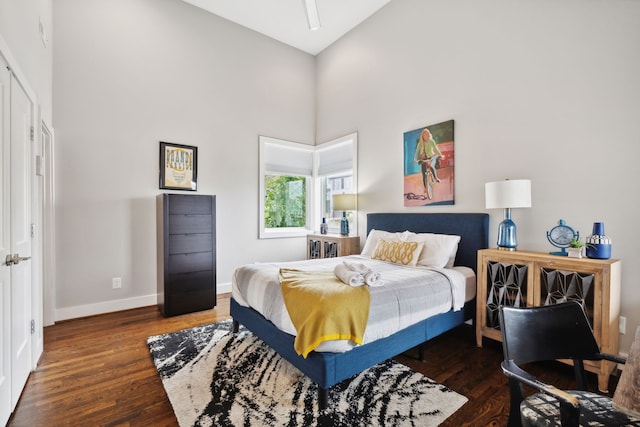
[147,321,467,427]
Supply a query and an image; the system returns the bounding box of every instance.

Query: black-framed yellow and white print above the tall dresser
[160,141,198,191]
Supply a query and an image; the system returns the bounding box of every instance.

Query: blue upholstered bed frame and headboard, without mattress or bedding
[230,213,489,408]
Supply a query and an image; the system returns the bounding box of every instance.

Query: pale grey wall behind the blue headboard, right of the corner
[317,0,640,350]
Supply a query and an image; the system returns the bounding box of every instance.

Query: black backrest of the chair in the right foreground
[499,301,601,364]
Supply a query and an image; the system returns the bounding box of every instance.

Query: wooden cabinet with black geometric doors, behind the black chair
[476,249,622,391]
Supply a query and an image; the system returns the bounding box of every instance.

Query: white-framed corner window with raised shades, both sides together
[259,133,357,239]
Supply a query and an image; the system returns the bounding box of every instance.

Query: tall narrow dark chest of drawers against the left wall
[156,193,216,316]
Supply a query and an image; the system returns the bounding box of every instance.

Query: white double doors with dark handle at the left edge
[0,55,33,423]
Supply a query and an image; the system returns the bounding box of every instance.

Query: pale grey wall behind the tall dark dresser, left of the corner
[54,0,315,318]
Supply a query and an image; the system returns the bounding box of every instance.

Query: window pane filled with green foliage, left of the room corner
[264,175,307,228]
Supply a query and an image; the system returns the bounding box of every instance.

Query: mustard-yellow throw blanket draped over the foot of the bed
[280,268,371,359]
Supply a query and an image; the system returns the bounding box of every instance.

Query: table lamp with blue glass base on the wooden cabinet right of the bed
[484,179,531,251]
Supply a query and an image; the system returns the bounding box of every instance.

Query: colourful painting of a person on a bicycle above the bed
[404,120,454,206]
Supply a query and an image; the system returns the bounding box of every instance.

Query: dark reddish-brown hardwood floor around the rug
[8,295,617,426]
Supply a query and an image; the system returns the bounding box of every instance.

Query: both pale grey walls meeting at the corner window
[51,0,640,349]
